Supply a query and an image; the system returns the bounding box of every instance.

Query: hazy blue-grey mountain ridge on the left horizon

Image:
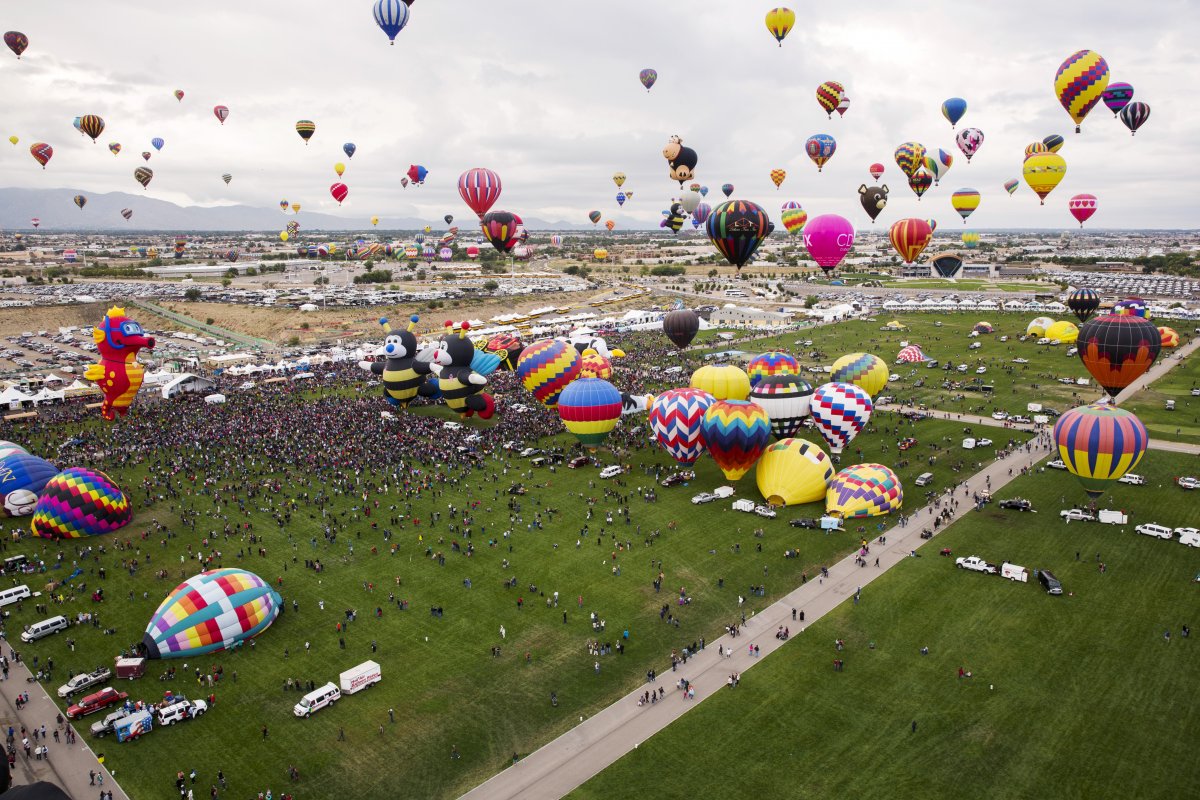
[0,188,592,231]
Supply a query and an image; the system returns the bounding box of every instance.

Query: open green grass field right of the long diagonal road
[569,451,1200,800]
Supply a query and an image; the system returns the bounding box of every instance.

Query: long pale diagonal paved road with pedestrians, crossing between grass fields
[463,435,1049,800]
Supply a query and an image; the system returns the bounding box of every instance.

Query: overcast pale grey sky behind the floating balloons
[0,0,1200,234]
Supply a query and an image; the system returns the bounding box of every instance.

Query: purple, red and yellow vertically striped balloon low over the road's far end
[1054,404,1150,500]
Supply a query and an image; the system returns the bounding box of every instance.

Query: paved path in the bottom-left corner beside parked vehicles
[0,645,130,800]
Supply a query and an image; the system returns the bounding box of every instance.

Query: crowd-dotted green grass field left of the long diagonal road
[6,396,1021,799]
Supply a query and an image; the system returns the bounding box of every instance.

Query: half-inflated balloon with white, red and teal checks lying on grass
[142,567,283,658]
